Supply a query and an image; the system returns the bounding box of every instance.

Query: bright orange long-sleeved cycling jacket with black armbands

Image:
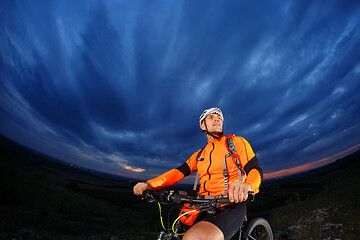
[147,136,262,196]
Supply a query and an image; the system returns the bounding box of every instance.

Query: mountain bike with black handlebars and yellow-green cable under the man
[138,190,274,240]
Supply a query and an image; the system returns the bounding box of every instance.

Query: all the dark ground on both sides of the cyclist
[0,136,360,240]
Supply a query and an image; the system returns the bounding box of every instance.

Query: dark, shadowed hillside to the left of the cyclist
[0,136,158,239]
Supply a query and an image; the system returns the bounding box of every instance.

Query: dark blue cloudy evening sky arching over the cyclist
[0,0,360,183]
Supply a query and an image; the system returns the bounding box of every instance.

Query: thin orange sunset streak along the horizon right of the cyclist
[264,144,360,179]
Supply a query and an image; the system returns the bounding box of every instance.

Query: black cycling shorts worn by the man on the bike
[196,203,246,240]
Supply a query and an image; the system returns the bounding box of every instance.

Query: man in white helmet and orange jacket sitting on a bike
[133,108,262,240]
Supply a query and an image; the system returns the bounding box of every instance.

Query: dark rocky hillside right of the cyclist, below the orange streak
[258,148,360,240]
